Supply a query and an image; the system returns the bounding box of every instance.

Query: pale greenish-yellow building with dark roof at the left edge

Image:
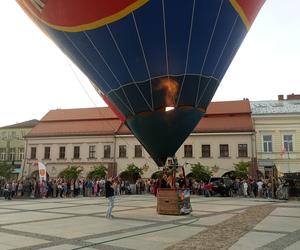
[0,120,38,174]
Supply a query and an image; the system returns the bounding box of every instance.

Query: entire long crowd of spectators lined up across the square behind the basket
[0,178,288,200]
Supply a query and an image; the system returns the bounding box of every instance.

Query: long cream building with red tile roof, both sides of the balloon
[22,100,255,181]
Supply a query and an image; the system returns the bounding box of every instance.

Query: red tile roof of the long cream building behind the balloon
[27,100,254,137]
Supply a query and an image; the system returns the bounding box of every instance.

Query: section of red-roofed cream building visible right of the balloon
[177,100,255,176]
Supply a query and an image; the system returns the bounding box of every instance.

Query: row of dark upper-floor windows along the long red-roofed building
[30,144,248,160]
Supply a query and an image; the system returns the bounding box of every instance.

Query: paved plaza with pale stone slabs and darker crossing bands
[0,195,300,250]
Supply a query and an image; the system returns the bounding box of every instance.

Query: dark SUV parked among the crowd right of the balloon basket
[209,177,233,197]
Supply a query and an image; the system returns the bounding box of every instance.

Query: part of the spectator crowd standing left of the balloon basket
[0,178,155,200]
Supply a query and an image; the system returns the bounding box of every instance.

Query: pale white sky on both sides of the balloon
[0,0,300,127]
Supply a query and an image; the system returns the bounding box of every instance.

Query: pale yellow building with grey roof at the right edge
[251,94,300,195]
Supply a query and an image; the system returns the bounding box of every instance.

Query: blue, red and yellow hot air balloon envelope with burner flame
[17,0,265,166]
